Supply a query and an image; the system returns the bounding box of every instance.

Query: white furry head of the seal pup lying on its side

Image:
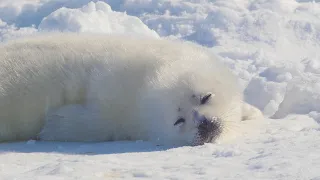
[141,58,241,145]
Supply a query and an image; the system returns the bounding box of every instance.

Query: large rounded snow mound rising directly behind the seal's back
[39,1,159,37]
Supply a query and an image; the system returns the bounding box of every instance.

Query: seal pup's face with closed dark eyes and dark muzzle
[173,93,222,145]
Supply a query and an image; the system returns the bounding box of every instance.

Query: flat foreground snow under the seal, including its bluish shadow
[0,115,320,180]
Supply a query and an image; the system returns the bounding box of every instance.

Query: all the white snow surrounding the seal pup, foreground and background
[0,0,320,180]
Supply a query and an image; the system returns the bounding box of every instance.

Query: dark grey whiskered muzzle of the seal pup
[192,117,222,146]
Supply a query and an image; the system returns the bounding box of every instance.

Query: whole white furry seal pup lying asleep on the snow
[0,33,261,145]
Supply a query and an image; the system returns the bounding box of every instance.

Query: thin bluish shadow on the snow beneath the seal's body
[0,141,180,155]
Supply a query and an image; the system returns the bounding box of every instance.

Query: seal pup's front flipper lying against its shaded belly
[36,104,105,141]
